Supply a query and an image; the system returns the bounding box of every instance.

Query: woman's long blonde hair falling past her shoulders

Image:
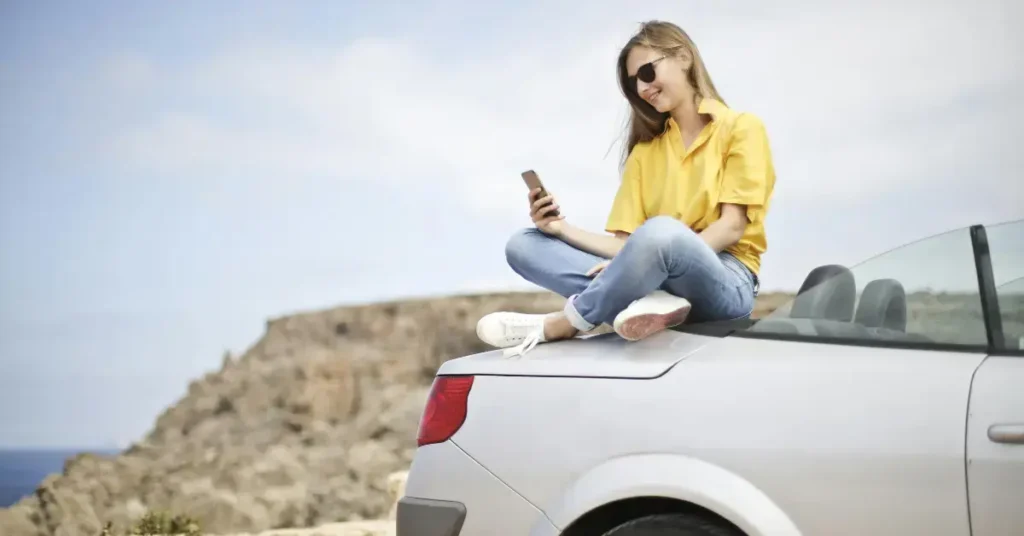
[617,20,725,164]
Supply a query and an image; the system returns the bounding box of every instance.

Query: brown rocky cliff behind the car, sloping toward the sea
[0,293,779,536]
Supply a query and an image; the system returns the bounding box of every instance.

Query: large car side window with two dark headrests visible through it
[745,229,987,349]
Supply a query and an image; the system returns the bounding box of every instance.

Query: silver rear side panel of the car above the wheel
[453,333,985,536]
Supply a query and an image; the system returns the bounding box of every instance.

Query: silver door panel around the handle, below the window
[967,357,1024,536]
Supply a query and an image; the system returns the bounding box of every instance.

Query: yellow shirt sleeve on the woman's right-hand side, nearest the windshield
[719,114,775,220]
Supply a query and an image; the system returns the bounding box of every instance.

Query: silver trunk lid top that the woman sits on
[437,330,716,379]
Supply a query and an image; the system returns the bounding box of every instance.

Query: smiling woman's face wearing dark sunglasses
[626,46,692,113]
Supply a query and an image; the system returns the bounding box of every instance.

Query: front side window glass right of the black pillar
[985,220,1024,352]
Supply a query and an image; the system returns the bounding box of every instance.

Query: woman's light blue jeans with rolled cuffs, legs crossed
[505,216,756,331]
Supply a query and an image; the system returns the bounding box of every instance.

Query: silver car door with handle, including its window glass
[967,221,1024,536]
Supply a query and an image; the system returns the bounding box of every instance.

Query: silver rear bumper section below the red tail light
[399,442,557,536]
